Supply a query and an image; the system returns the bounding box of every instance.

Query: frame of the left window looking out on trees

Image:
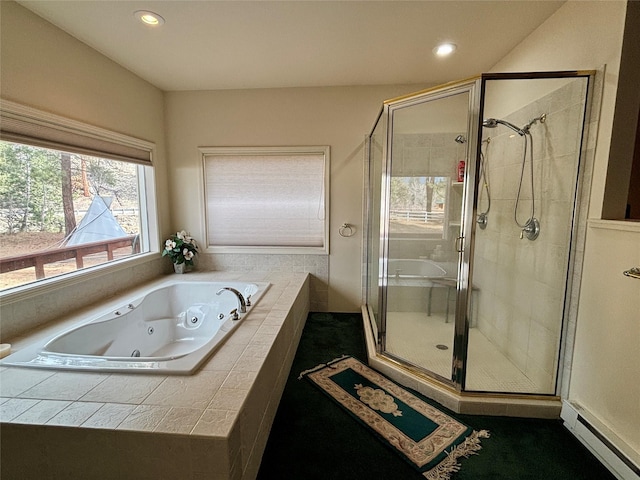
[0,100,160,304]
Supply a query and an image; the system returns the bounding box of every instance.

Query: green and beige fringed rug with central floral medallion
[299,357,489,480]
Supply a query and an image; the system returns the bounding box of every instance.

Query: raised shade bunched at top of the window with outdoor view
[0,101,151,165]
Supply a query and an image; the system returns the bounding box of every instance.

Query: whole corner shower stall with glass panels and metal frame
[363,72,594,399]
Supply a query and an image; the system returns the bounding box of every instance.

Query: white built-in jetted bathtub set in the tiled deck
[0,280,269,375]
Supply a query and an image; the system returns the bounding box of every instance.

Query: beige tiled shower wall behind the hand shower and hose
[469,81,586,393]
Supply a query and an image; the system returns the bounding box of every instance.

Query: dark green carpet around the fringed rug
[258,313,615,480]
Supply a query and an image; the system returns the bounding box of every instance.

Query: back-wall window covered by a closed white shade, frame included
[200,147,329,253]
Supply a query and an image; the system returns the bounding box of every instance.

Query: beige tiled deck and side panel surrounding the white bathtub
[0,272,309,480]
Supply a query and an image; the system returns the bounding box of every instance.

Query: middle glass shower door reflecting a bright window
[381,82,472,382]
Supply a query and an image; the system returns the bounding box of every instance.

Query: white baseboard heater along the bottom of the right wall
[560,401,640,480]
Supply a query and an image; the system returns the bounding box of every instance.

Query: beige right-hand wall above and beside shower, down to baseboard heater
[492,1,640,458]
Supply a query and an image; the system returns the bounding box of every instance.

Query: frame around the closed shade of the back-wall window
[198,145,331,255]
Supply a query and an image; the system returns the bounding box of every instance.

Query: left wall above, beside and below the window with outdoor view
[0,1,169,334]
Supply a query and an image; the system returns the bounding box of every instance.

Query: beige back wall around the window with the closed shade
[166,85,424,312]
